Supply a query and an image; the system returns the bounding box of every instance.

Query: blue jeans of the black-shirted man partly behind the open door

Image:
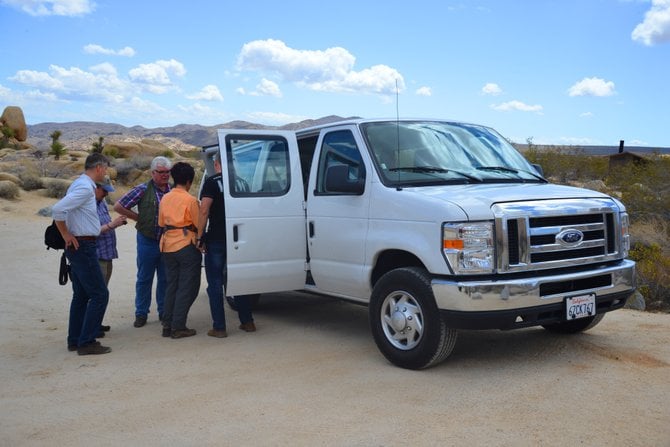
[205,241,254,331]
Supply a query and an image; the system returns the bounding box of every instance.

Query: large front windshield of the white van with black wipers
[361,121,546,186]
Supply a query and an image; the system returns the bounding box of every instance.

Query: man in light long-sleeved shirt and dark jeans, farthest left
[52,153,112,355]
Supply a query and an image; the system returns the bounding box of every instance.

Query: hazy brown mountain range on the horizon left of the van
[28,115,356,150]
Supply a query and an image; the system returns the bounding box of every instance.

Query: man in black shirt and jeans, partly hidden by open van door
[197,153,256,338]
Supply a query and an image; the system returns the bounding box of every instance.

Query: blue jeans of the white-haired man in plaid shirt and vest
[135,232,167,317]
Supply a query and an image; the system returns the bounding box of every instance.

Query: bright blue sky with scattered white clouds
[0,0,670,147]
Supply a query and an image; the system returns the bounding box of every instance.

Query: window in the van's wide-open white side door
[226,135,290,197]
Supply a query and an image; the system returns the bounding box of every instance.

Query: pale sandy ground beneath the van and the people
[0,192,670,446]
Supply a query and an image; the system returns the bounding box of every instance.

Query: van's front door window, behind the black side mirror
[314,130,365,195]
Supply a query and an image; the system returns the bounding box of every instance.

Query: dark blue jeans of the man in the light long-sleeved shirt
[65,239,109,346]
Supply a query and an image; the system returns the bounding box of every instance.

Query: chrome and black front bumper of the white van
[432,259,636,329]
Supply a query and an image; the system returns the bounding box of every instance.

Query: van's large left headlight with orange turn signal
[442,222,495,275]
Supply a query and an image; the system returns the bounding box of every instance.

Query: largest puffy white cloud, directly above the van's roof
[237,39,405,94]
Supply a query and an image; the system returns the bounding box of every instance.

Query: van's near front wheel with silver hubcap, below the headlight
[368,267,458,369]
